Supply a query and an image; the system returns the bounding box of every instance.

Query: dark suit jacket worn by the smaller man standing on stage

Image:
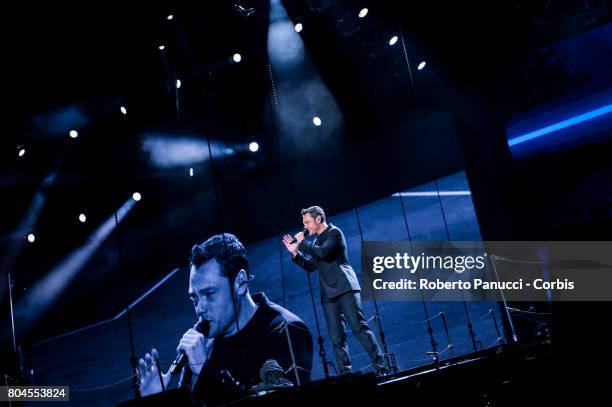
[293,223,361,301]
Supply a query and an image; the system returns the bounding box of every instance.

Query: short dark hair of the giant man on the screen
[190,233,251,285]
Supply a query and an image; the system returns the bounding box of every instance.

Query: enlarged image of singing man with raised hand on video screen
[139,233,312,405]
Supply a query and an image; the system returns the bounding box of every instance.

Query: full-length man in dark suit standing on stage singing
[283,206,386,374]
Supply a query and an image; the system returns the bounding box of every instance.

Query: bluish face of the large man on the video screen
[189,259,234,338]
